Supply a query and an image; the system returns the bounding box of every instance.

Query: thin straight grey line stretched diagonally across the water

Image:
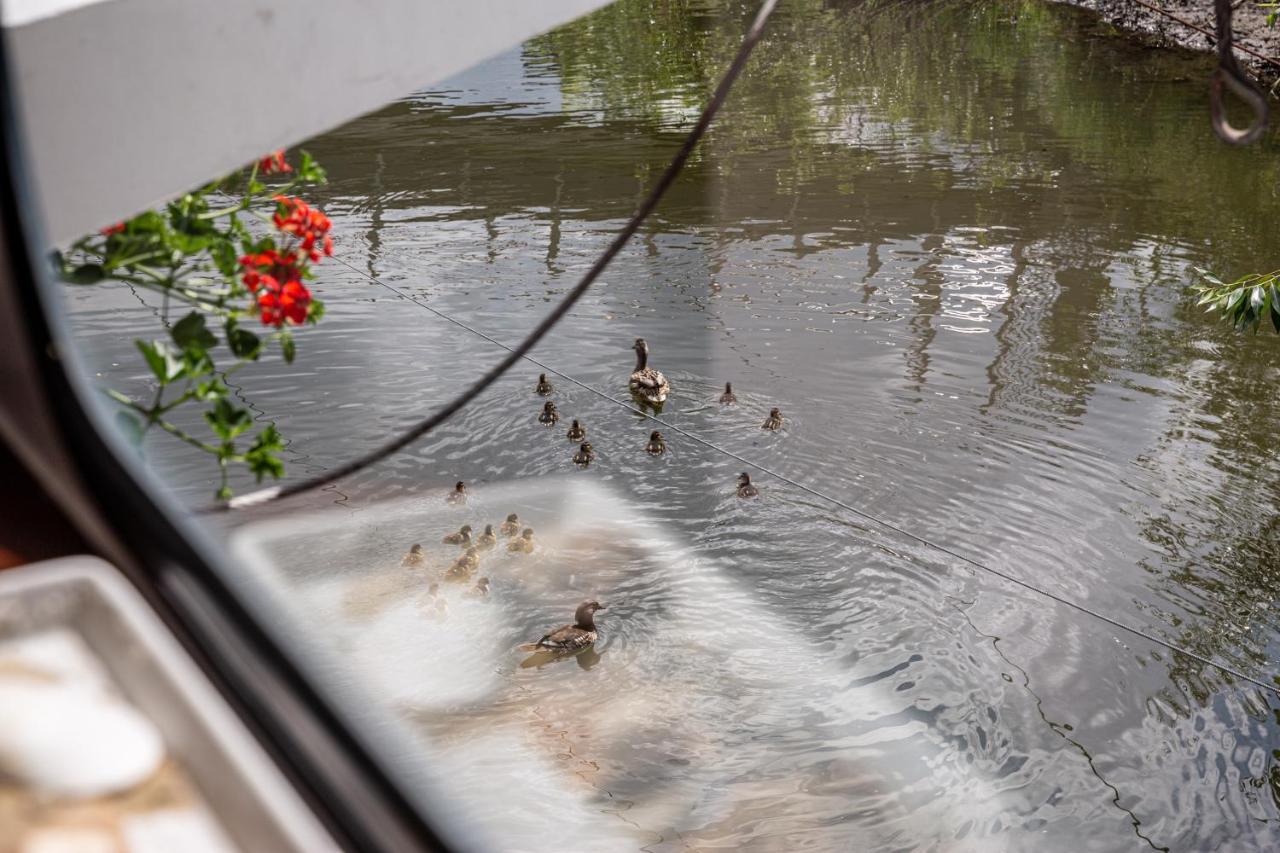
[320,251,1280,695]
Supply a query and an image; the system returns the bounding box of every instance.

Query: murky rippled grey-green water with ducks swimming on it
[64,0,1280,850]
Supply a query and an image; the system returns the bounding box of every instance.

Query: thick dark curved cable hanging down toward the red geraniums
[212,0,778,512]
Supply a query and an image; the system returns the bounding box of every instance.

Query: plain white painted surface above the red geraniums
[4,0,605,243]
